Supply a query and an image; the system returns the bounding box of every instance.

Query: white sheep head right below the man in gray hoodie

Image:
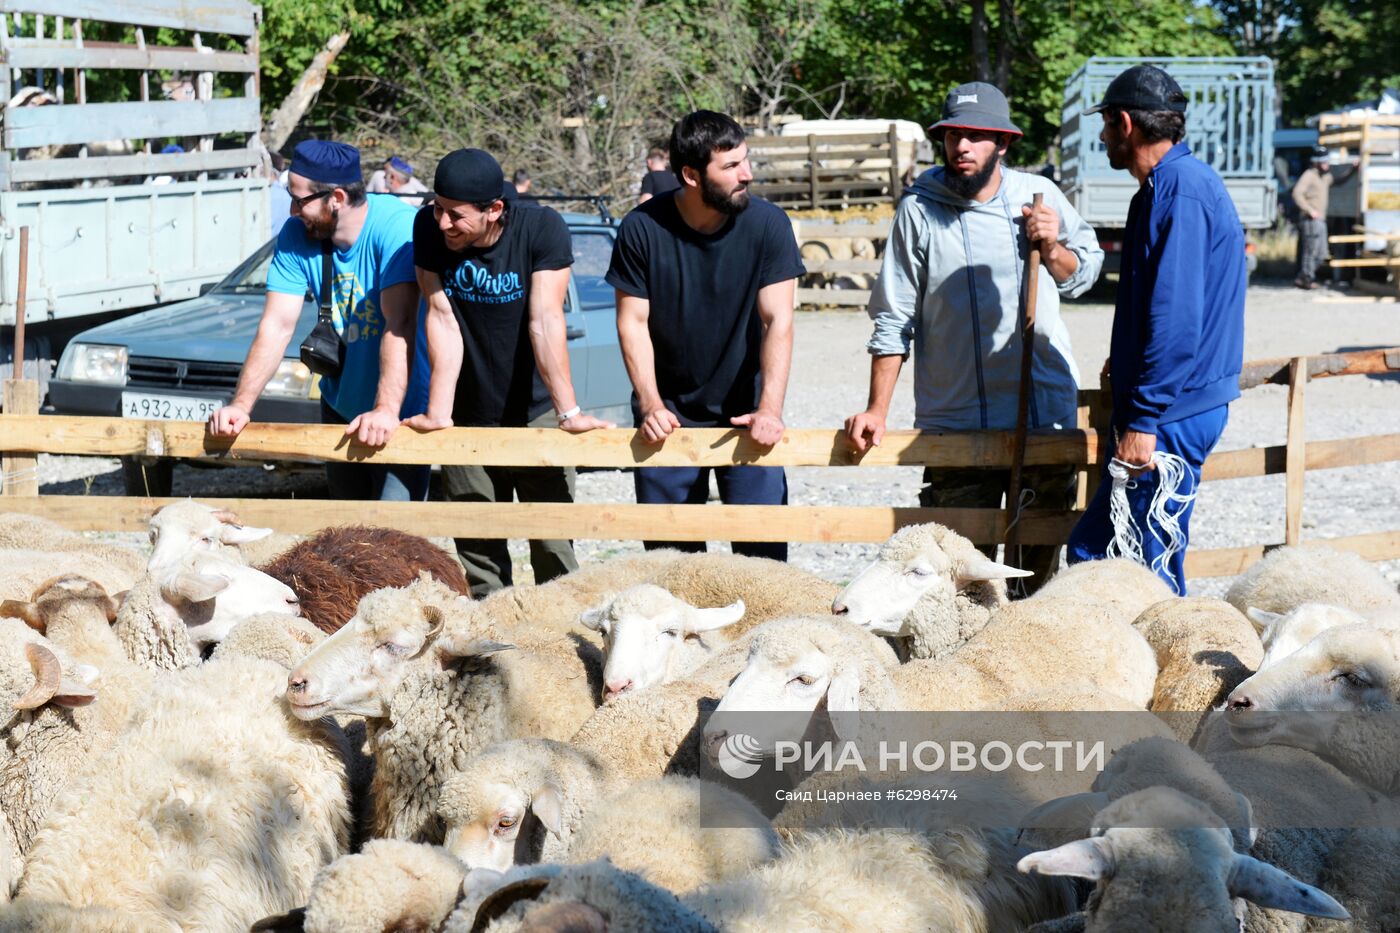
[832,523,1030,636]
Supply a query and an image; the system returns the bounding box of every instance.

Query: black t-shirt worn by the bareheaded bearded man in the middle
[608,195,806,427]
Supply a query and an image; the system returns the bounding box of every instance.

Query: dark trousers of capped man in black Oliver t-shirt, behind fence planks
[442,412,578,598]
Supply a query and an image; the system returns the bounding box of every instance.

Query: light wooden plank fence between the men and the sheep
[0,347,1400,577]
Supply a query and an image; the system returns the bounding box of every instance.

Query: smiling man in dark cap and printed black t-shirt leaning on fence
[406,148,613,597]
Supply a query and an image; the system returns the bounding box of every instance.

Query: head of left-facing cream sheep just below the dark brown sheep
[287,573,514,720]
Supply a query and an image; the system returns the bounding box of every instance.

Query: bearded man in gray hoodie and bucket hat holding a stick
[846,83,1103,594]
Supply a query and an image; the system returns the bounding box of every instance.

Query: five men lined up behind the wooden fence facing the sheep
[210,66,1246,595]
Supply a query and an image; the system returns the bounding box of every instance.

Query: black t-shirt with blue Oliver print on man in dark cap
[413,203,574,427]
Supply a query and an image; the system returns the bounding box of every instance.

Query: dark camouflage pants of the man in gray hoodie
[918,467,1079,595]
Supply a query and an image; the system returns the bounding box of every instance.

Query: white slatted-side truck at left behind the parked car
[0,0,270,394]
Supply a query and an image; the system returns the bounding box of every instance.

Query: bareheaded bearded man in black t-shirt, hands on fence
[608,111,805,560]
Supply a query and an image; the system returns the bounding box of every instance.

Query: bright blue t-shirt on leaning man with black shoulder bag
[267,195,428,420]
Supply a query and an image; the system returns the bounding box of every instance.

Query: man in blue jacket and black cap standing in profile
[1068,64,1247,595]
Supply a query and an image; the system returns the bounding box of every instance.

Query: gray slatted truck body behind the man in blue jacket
[1060,56,1278,272]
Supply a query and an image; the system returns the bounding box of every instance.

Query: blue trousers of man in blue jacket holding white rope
[1067,405,1229,595]
